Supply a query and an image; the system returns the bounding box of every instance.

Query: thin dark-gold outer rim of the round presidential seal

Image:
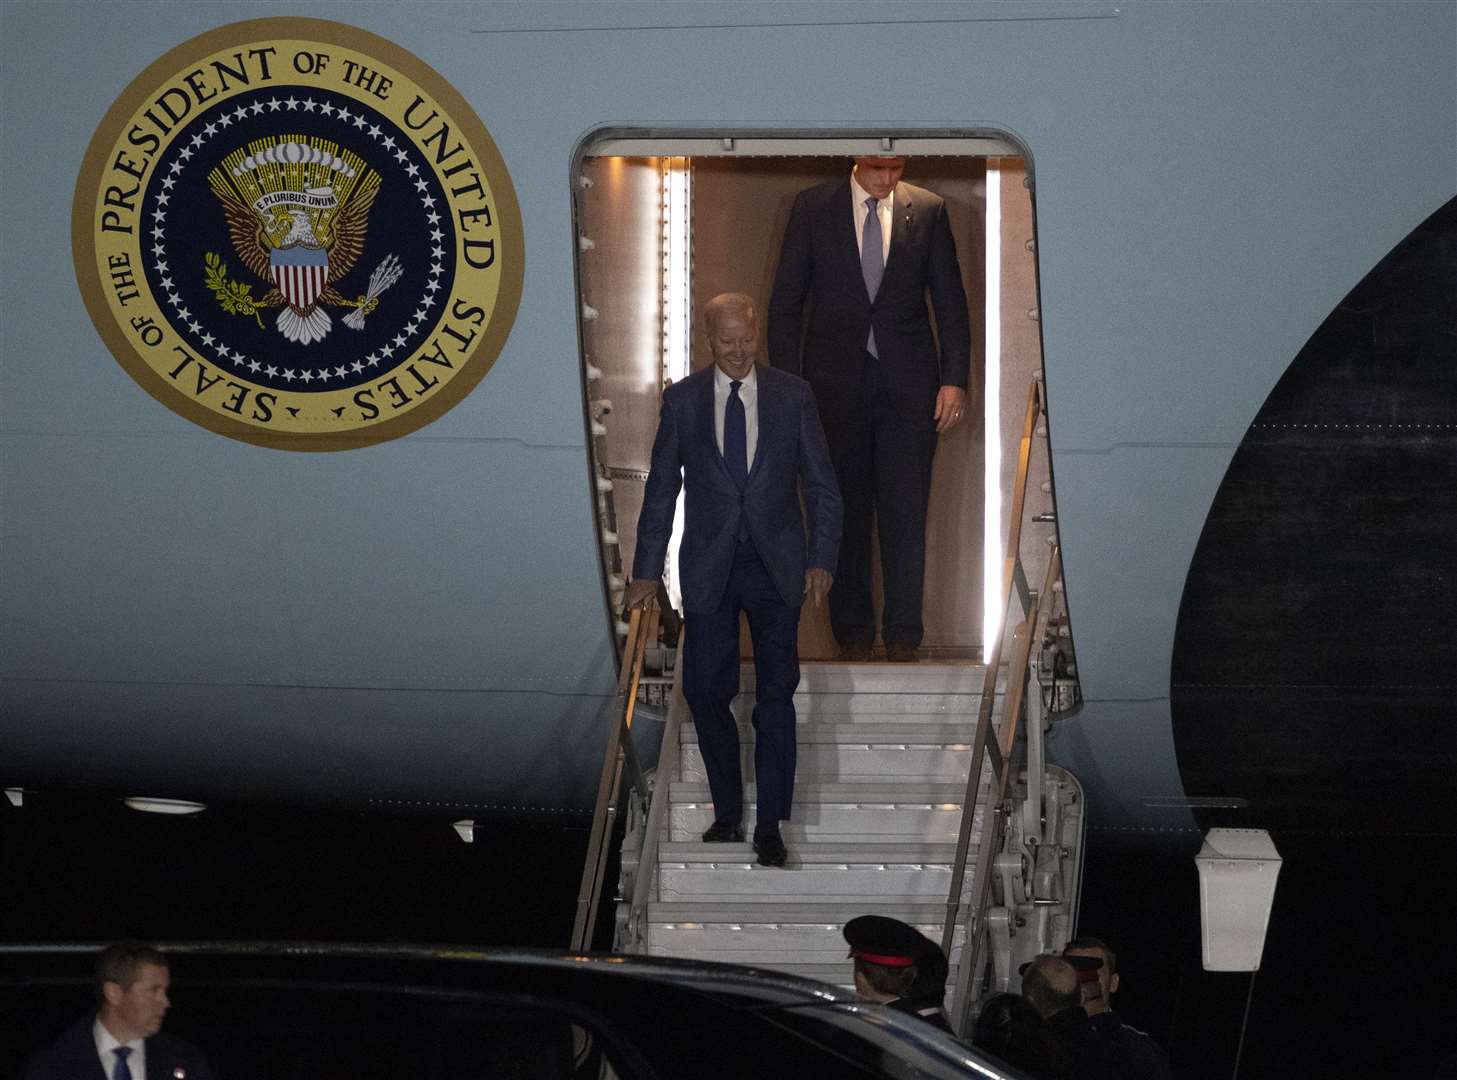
[71,17,526,450]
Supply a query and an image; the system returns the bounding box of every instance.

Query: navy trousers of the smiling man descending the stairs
[683,539,800,834]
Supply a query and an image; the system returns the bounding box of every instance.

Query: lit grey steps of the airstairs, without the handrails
[637,663,1000,988]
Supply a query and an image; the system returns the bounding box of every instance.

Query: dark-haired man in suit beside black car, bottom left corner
[20,942,213,1080]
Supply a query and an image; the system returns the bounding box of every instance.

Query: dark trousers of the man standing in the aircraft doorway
[825,353,937,649]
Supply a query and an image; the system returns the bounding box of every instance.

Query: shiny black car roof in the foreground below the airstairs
[0,943,1021,1080]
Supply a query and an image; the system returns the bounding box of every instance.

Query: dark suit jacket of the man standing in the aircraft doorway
[769,176,972,424]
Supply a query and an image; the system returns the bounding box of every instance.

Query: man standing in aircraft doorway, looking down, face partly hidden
[769,157,972,660]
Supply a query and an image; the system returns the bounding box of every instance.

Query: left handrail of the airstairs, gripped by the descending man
[571,608,661,952]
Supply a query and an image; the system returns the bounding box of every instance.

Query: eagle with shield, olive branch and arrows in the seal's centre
[207,137,402,345]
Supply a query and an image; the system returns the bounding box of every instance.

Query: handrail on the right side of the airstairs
[941,377,1062,1032]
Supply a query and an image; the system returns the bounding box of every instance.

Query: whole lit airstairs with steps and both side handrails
[574,383,1084,1030]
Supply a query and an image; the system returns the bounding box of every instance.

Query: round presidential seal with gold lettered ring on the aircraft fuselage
[71,19,525,450]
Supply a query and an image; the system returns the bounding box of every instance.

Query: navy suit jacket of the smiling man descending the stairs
[632,364,844,612]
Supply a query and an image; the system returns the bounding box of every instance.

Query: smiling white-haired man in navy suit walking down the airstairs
[624,293,844,866]
